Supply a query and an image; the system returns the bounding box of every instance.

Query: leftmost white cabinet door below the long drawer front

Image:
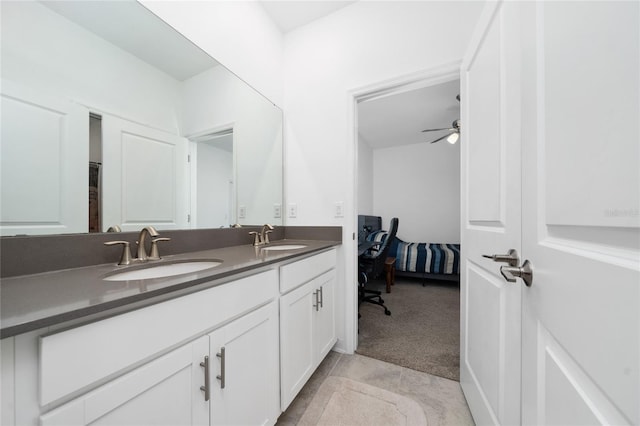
[41,336,209,426]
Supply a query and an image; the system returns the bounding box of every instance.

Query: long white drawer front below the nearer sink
[39,270,278,405]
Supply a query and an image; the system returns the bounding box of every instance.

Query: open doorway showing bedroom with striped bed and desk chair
[355,67,460,380]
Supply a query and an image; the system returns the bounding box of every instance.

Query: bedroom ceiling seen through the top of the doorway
[358,80,460,149]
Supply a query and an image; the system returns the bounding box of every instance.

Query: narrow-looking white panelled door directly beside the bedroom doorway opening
[460,3,522,424]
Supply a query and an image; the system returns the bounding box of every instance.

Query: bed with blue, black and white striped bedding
[358,215,460,285]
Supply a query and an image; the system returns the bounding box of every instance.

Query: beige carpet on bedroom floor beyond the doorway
[357,277,460,381]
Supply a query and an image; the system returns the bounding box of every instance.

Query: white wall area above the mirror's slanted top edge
[140,0,283,106]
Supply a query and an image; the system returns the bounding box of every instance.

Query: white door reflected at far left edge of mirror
[0,80,89,235]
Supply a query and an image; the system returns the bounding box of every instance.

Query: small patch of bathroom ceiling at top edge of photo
[260,0,355,34]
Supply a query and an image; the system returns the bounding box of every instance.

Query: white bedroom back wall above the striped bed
[370,141,460,243]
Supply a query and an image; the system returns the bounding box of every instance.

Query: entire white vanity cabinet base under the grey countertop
[0,249,336,426]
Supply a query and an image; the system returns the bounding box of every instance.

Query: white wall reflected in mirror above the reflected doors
[2,2,180,133]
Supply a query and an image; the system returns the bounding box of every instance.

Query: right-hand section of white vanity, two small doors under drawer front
[280,250,336,411]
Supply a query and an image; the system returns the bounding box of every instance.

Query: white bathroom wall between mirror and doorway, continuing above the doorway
[284,1,483,351]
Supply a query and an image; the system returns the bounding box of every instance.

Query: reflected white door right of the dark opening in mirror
[102,115,189,231]
